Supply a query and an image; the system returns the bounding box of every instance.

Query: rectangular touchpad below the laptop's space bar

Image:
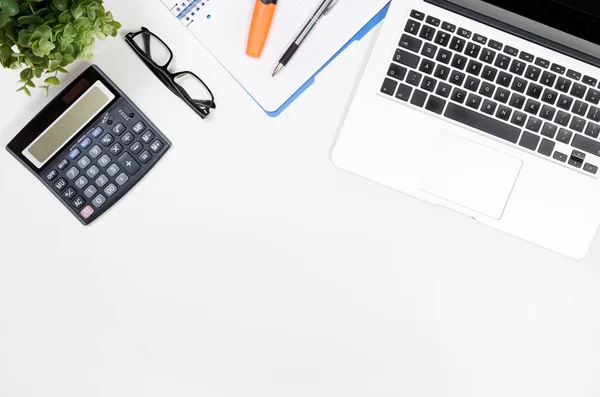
[419,131,523,219]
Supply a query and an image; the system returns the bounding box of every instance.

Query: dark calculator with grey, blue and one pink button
[6,65,171,225]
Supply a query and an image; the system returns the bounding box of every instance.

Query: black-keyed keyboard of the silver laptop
[380,10,600,175]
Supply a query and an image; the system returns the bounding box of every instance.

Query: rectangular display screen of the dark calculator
[23,81,115,168]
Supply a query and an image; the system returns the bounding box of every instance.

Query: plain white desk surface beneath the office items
[0,0,600,397]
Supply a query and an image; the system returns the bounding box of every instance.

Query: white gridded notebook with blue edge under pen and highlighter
[161,0,390,116]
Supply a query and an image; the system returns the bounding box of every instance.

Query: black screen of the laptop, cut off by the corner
[448,0,600,58]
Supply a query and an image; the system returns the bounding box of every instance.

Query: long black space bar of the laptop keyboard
[444,102,524,145]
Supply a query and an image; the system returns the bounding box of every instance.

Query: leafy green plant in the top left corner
[0,0,121,96]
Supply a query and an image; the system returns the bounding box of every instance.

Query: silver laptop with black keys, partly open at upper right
[332,0,600,259]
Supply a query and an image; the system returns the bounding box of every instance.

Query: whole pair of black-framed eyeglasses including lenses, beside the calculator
[125,27,216,119]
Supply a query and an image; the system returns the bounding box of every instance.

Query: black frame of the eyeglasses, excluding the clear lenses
[125,27,217,119]
